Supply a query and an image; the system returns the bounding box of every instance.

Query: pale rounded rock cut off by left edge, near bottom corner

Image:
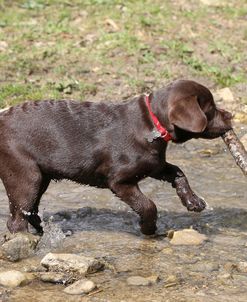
[0,270,29,288]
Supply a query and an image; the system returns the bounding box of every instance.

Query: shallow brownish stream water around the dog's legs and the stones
[0,126,247,302]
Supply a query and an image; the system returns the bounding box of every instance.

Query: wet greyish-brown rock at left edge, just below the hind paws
[0,233,40,262]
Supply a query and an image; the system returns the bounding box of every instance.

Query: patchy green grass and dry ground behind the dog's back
[0,0,247,107]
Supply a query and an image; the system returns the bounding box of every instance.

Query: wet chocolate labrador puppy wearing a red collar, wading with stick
[0,80,232,235]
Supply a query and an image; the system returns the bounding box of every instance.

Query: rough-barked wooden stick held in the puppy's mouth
[222,130,247,176]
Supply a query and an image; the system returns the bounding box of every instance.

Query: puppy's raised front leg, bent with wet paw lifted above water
[154,163,206,212]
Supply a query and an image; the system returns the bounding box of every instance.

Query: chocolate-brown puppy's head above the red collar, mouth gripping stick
[161,80,232,142]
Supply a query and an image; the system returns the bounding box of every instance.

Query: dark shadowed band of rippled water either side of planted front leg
[44,207,247,235]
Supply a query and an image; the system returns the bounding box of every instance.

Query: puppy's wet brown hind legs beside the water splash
[0,154,45,233]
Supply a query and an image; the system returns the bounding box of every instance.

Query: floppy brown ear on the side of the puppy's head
[168,96,207,133]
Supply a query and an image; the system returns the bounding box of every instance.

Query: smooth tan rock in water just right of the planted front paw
[170,229,207,245]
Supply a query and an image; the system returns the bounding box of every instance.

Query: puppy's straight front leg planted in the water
[110,183,157,235]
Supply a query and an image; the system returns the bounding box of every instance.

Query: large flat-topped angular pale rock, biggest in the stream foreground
[41,253,104,276]
